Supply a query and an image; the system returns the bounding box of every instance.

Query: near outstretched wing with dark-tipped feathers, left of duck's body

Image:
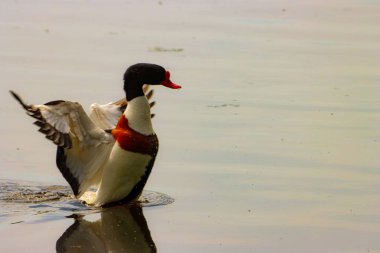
[11,91,115,197]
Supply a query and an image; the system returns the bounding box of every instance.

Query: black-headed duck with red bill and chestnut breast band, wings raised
[10,63,181,207]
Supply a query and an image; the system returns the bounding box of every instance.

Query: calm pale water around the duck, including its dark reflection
[0,0,380,252]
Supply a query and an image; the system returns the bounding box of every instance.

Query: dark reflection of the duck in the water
[56,205,157,253]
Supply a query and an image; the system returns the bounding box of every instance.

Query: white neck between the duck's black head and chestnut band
[124,96,154,135]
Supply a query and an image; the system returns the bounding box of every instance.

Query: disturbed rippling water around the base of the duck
[0,180,174,221]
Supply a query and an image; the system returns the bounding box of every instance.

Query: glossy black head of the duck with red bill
[124,63,181,101]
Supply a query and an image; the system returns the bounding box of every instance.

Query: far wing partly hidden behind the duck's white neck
[89,85,155,130]
